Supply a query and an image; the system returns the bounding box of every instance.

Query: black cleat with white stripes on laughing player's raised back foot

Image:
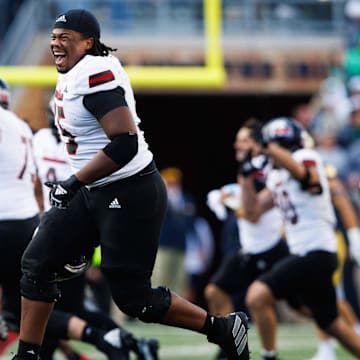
[207,312,250,360]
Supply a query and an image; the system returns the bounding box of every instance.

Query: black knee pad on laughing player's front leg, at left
[20,274,60,303]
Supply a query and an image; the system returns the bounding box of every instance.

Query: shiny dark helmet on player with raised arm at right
[261,117,305,151]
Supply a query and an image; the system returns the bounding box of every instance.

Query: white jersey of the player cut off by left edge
[0,106,39,220]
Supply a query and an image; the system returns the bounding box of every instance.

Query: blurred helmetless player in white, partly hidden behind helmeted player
[205,119,289,359]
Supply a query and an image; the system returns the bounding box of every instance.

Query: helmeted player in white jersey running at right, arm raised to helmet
[241,118,360,359]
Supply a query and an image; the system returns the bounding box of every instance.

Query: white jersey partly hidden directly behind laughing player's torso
[33,129,71,211]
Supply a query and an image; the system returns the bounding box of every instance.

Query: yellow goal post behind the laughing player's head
[0,0,226,89]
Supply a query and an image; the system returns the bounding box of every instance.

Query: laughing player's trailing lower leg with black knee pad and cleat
[104,270,249,360]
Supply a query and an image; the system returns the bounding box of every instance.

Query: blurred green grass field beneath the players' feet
[1,322,355,360]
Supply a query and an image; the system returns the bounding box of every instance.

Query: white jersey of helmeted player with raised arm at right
[267,149,336,255]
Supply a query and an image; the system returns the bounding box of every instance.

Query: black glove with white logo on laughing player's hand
[45,175,84,209]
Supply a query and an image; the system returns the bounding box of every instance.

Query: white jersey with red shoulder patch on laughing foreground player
[55,55,153,187]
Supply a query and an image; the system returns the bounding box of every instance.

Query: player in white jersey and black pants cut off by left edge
[0,80,39,340]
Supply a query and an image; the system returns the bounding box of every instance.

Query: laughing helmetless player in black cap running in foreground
[10,9,249,360]
